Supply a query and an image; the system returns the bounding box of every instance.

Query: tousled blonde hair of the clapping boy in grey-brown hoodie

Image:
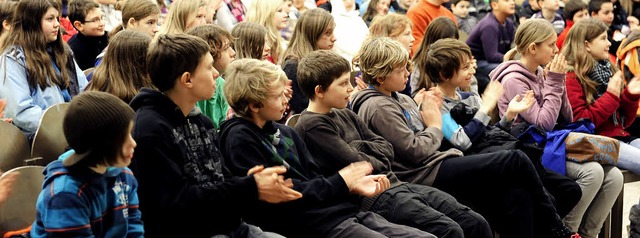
[353,37,409,85]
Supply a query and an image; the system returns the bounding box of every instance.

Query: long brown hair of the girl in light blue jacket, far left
[0,0,69,90]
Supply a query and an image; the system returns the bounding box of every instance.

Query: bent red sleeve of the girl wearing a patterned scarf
[567,74,620,128]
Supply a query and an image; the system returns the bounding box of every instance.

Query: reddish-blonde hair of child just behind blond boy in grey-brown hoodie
[369,13,412,38]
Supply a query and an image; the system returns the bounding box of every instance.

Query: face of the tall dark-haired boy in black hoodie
[190,52,220,101]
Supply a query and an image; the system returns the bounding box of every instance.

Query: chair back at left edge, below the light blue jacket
[0,120,31,171]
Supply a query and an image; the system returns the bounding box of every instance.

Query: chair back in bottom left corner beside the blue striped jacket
[0,166,44,236]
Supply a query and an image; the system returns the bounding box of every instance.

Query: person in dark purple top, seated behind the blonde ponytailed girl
[467,0,516,94]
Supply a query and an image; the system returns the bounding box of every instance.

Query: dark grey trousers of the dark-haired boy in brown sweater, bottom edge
[369,183,493,238]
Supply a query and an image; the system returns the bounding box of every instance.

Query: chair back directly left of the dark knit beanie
[28,103,69,166]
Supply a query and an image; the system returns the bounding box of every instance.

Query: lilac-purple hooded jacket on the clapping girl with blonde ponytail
[489,60,573,131]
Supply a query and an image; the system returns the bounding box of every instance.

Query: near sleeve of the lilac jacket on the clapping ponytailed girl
[503,72,564,131]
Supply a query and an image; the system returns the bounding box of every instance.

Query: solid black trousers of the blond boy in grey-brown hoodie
[433,150,563,238]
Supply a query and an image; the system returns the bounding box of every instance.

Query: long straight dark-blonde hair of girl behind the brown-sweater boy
[284,8,336,60]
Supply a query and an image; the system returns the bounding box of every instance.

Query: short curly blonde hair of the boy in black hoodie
[224,59,288,118]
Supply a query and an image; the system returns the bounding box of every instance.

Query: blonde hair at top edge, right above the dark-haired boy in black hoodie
[157,0,206,37]
